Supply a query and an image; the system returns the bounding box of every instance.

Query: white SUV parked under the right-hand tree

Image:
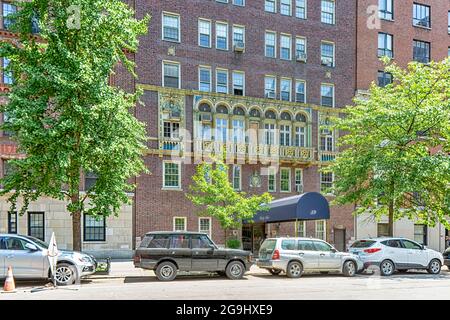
[349,238,444,276]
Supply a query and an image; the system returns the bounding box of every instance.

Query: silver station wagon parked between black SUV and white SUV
[256,238,364,278]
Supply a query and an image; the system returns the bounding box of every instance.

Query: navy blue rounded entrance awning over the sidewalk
[253,192,330,223]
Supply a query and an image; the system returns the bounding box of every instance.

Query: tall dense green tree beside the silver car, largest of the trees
[0,0,149,250]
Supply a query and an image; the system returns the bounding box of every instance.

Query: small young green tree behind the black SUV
[186,159,272,243]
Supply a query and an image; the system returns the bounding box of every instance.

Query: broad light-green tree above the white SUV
[325,59,450,235]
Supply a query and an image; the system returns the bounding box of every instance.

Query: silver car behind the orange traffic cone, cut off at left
[0,234,97,285]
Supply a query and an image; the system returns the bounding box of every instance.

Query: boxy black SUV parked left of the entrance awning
[134,231,253,281]
